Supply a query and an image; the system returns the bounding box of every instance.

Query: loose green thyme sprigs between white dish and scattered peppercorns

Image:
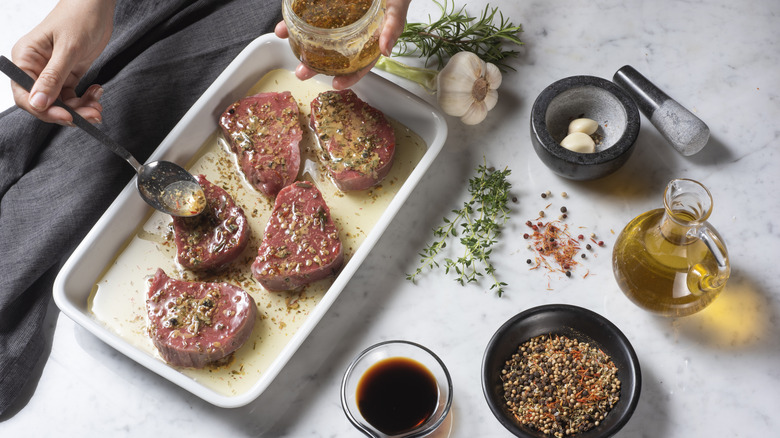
[406,159,512,296]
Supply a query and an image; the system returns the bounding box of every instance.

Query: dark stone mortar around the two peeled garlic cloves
[531,76,640,180]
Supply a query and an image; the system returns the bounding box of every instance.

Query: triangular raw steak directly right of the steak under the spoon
[252,182,344,291]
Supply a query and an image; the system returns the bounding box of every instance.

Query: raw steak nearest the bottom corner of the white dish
[146,269,257,368]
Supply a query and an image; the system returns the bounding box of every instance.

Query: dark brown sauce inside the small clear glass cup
[357,357,439,435]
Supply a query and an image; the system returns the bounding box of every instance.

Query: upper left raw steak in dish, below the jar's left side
[219,91,303,198]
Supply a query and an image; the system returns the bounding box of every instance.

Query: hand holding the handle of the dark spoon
[11,0,115,125]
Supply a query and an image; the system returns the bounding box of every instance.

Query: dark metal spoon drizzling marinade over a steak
[0,56,206,216]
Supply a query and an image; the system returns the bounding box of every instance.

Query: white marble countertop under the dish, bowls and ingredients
[0,0,780,437]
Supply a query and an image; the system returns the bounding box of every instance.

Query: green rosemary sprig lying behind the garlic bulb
[395,0,523,72]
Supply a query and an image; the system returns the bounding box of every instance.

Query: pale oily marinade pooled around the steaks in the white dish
[88,70,427,396]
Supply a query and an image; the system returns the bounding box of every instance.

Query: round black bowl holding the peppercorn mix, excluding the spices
[482,304,642,438]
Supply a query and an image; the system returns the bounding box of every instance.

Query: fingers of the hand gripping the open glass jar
[274,0,412,90]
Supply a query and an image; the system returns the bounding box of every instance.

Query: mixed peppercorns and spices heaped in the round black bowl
[501,335,620,438]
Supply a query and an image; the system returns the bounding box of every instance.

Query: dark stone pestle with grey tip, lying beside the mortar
[612,65,710,156]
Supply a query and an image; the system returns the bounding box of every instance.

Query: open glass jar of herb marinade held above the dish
[282,0,386,76]
